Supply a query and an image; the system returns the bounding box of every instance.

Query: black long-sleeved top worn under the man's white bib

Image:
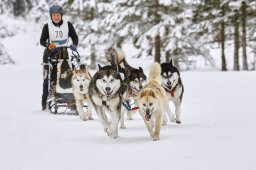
[40,20,78,47]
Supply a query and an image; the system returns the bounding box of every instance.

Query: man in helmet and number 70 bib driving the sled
[40,5,78,110]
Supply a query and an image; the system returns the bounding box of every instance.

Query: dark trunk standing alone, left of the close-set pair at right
[220,5,227,71]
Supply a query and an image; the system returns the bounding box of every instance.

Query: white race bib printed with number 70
[48,21,69,47]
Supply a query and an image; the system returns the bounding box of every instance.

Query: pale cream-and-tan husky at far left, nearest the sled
[72,66,93,121]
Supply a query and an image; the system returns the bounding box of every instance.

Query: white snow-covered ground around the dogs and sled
[0,19,256,170]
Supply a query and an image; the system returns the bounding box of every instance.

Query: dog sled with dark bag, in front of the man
[44,49,87,115]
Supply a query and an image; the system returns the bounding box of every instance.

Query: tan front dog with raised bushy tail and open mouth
[136,62,168,141]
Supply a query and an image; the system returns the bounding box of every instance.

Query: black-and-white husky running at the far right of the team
[161,60,184,124]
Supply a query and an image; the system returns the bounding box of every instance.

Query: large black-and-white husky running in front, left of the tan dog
[89,65,126,139]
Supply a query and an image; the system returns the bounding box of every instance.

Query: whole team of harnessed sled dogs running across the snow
[72,48,184,141]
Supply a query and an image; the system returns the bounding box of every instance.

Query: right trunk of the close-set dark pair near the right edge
[241,1,248,70]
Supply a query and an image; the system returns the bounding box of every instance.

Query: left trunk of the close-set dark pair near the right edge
[233,10,240,71]
